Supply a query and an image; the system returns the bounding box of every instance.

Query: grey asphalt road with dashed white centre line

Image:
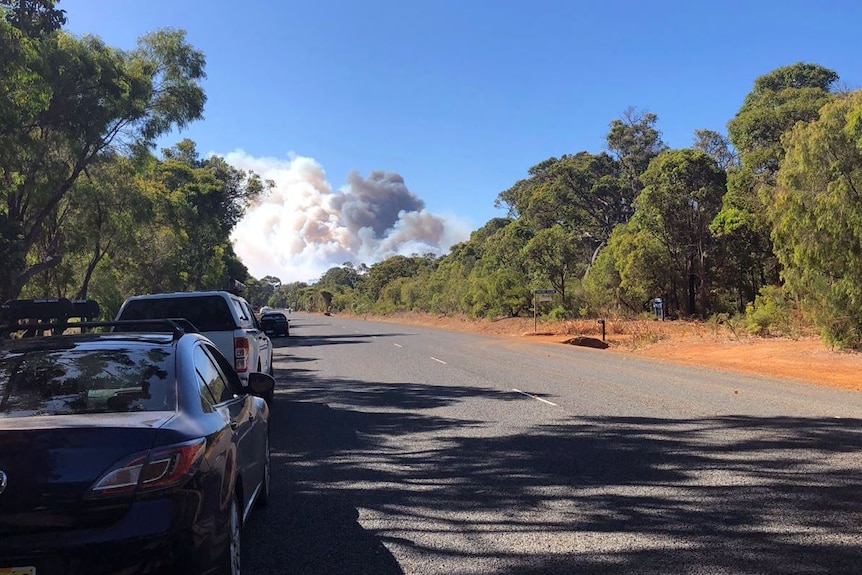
[243,313,862,575]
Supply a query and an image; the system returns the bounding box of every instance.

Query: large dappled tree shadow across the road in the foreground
[253,370,862,575]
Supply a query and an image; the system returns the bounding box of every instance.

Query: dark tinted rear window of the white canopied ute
[118,295,236,331]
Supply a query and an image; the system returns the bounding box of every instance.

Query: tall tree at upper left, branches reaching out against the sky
[0,0,205,299]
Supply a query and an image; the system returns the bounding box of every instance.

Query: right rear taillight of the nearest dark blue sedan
[87,437,207,499]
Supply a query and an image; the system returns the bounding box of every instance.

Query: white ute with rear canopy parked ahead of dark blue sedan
[116,291,273,399]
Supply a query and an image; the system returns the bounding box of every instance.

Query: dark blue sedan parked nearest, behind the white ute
[0,300,274,575]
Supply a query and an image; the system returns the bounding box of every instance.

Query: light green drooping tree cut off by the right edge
[770,91,862,349]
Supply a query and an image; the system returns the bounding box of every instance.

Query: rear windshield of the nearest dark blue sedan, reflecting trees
[0,347,176,419]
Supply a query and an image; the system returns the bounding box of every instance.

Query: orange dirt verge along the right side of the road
[352,313,862,391]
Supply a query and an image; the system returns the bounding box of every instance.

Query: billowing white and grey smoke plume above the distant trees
[224,150,470,283]
